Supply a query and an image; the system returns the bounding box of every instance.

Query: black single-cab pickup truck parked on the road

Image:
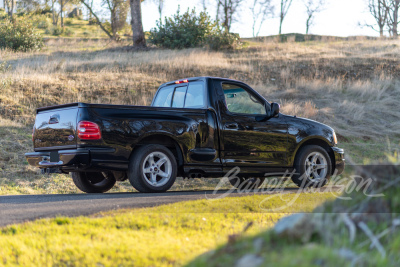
[25,77,344,193]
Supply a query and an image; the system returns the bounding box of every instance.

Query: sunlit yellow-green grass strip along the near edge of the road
[0,193,334,266]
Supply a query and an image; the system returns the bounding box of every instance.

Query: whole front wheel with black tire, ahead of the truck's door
[292,145,332,188]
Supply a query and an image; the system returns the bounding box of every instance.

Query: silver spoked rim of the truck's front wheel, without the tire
[305,152,328,181]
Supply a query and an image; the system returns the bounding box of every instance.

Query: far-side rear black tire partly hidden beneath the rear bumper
[70,172,116,193]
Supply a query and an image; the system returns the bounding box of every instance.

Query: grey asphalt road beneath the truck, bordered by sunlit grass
[0,187,339,226]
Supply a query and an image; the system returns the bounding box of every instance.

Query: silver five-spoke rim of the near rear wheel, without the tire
[142,152,172,187]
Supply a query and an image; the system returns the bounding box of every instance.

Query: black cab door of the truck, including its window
[220,83,288,167]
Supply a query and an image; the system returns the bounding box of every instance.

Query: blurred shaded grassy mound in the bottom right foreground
[188,162,400,267]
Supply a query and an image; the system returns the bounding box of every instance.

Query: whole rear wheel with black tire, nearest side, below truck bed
[128,145,178,193]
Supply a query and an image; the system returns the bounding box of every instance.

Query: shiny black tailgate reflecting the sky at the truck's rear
[33,105,78,151]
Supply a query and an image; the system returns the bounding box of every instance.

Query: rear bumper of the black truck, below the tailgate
[25,148,115,173]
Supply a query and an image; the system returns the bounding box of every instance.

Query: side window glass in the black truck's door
[222,83,266,115]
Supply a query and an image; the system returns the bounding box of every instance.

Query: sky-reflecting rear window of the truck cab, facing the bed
[152,81,206,109]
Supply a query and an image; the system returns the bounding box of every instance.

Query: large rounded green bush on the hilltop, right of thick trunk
[149,9,240,50]
